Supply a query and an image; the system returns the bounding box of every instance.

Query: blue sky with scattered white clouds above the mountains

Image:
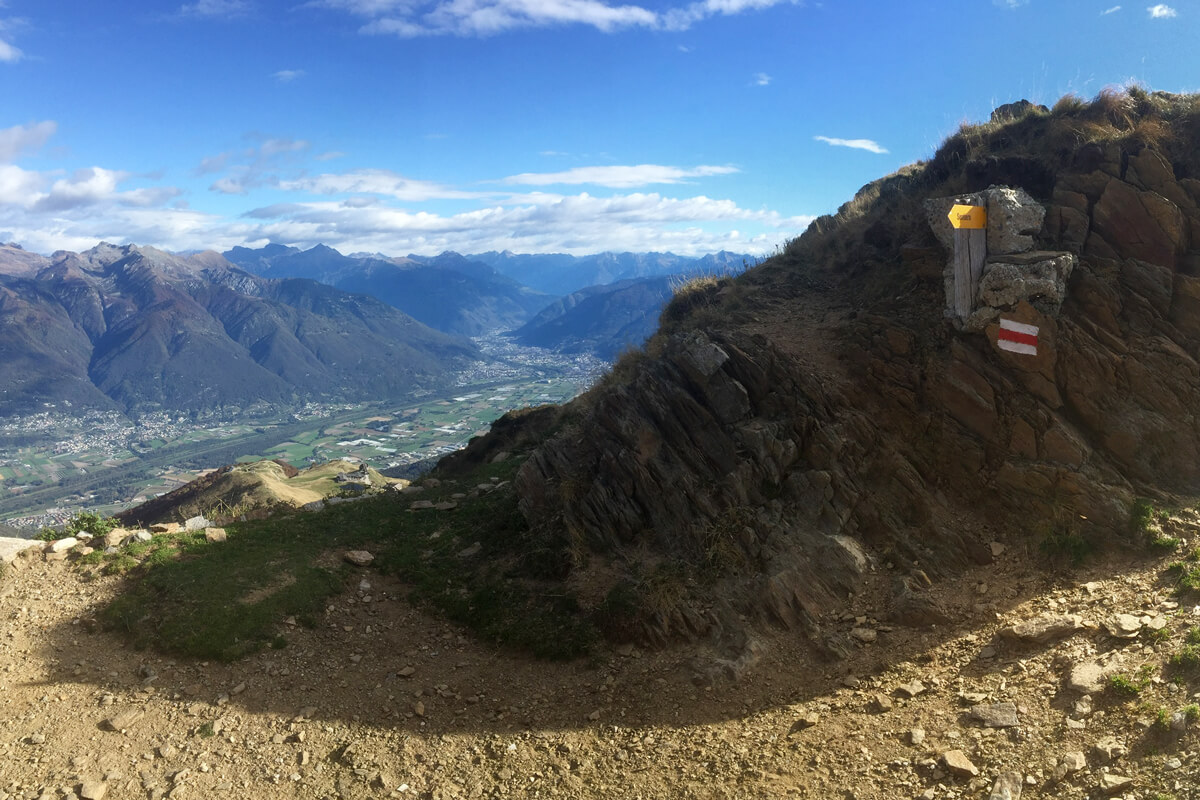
[0,0,1200,254]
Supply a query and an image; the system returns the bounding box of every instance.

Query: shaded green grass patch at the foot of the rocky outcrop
[97,459,596,661]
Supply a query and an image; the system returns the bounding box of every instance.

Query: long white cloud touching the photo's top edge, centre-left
[308,0,799,38]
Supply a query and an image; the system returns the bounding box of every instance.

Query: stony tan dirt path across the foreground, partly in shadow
[0,525,1200,800]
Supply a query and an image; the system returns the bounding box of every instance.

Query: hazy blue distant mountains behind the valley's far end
[224,245,754,357]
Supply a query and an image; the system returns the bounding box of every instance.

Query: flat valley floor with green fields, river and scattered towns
[0,378,584,519]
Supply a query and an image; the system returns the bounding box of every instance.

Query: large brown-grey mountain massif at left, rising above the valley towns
[0,243,479,413]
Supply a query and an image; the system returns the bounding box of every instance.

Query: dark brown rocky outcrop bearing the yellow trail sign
[472,92,1200,651]
